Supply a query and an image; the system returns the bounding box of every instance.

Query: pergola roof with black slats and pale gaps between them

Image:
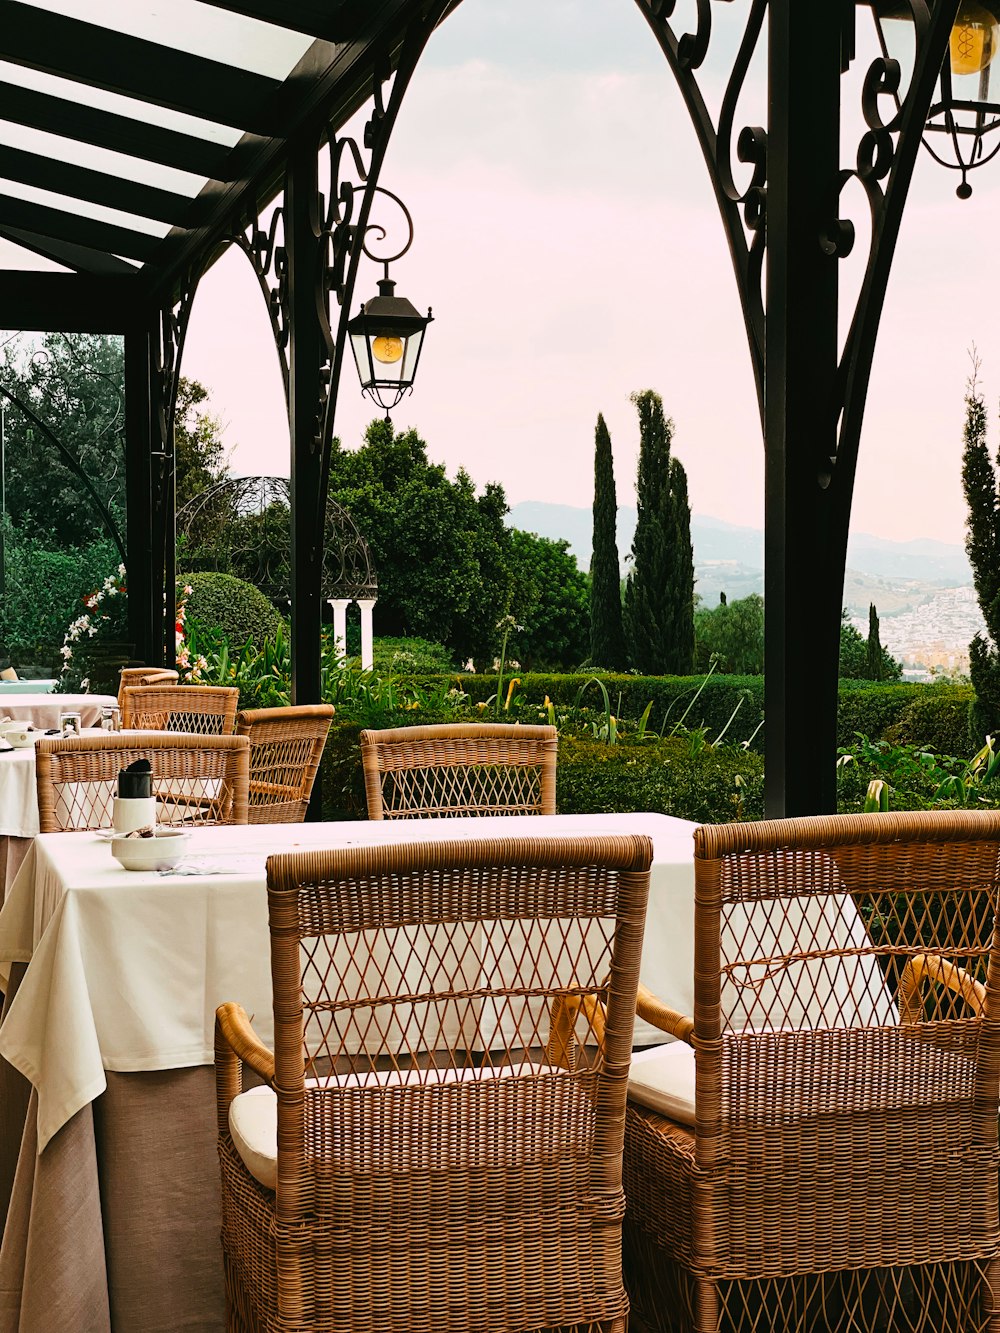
[0,0,450,328]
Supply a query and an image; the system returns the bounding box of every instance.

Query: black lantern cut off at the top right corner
[872,0,1000,199]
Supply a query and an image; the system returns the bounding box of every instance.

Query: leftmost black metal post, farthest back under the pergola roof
[125,328,161,665]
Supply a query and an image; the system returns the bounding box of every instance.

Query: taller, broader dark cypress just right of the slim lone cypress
[624,389,695,676]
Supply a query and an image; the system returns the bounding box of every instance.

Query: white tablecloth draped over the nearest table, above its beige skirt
[0,814,895,1150]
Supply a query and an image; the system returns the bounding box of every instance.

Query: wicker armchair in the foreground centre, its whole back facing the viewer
[216,836,652,1333]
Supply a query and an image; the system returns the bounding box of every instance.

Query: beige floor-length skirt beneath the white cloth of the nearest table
[0,966,225,1333]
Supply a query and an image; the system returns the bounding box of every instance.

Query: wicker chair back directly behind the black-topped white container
[35,732,249,833]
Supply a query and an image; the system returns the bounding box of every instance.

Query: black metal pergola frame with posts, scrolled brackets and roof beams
[0,0,1000,816]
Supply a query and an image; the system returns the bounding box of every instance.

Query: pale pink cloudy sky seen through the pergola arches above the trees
[1,0,1000,543]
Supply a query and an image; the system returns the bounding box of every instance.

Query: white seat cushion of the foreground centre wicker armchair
[229,1064,586,1189]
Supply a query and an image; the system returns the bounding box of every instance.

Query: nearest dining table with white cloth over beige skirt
[0,813,892,1333]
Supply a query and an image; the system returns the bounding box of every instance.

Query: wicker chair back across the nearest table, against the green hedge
[361,722,559,820]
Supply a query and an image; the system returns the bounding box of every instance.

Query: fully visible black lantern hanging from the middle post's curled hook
[347,273,433,413]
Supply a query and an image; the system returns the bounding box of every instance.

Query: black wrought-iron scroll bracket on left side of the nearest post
[636,0,768,420]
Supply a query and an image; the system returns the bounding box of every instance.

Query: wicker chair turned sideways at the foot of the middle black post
[236,704,333,824]
